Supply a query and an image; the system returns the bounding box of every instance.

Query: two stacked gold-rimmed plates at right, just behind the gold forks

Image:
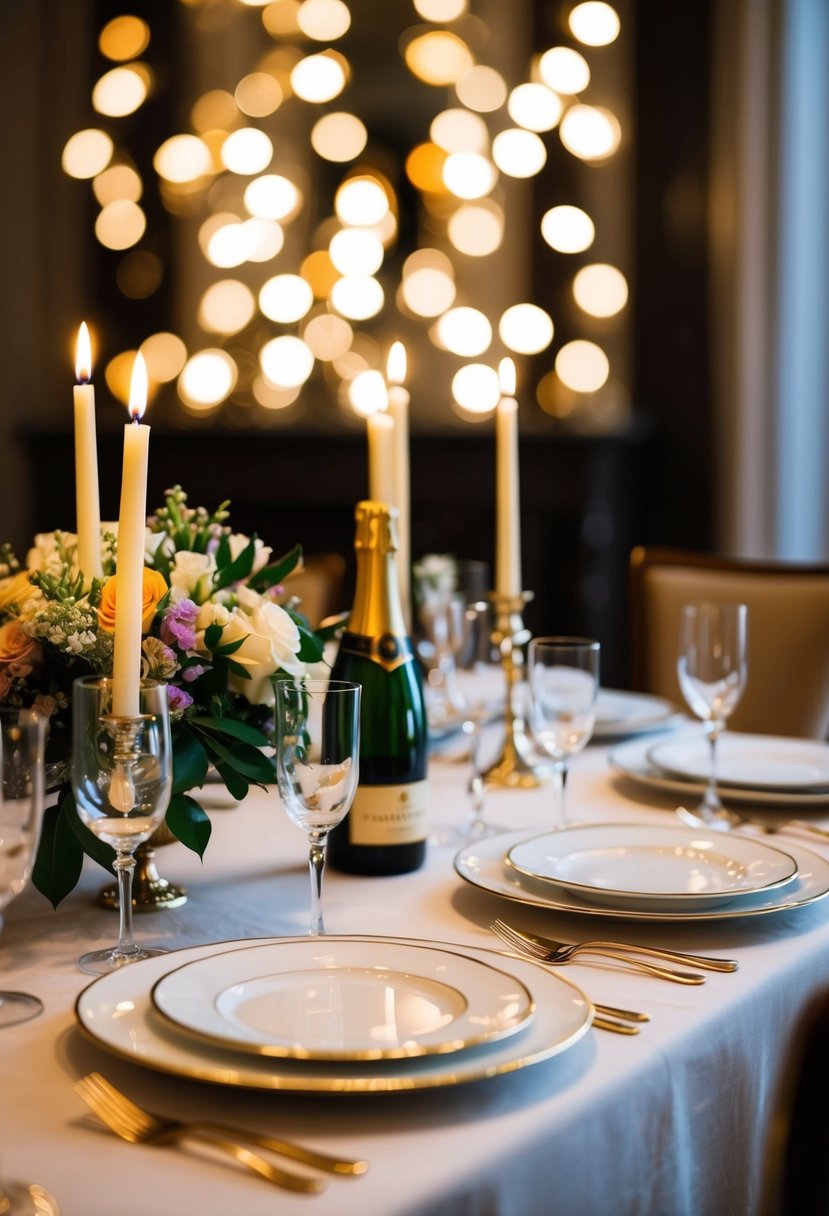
[455,823,829,921]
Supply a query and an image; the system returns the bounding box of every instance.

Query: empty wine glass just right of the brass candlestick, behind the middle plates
[528,637,600,824]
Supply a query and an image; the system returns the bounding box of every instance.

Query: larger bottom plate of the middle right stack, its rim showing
[455,832,829,922]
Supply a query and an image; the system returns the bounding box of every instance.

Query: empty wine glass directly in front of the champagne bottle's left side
[273,679,362,936]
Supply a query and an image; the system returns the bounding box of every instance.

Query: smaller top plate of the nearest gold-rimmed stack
[151,938,534,1060]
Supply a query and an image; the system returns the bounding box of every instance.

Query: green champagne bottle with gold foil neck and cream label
[328,501,429,874]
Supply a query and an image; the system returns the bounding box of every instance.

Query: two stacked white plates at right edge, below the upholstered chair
[610,730,829,809]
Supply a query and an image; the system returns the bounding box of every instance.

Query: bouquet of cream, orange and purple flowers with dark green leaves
[0,486,326,906]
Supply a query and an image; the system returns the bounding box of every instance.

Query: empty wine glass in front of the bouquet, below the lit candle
[72,676,173,975]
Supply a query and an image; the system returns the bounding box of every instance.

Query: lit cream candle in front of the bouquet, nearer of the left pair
[112,354,150,717]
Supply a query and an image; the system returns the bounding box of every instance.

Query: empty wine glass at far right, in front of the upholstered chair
[677,601,749,828]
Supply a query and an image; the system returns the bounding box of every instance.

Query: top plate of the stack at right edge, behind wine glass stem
[648,731,829,793]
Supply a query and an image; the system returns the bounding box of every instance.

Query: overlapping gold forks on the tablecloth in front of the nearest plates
[75,1073,368,1193]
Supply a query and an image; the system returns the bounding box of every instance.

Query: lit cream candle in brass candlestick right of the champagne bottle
[495,359,521,596]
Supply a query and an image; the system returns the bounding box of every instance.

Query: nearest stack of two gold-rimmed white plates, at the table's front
[75,936,592,1093]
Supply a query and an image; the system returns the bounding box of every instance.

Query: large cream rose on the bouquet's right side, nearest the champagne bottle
[196,589,304,705]
